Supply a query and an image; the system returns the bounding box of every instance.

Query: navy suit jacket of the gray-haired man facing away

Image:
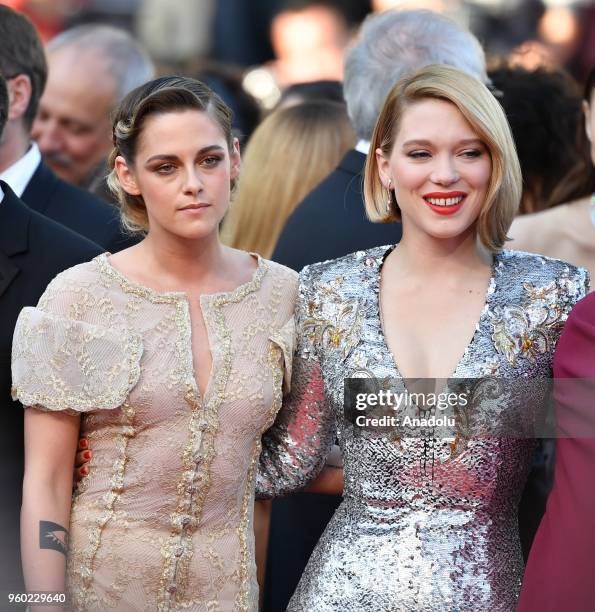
[271,149,401,270]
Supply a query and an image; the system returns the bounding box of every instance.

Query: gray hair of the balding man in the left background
[47,25,155,106]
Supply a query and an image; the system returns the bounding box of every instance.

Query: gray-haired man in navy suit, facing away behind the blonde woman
[272,10,487,270]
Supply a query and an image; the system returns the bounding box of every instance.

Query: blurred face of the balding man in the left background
[32,48,116,187]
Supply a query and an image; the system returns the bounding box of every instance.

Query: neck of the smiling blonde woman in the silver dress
[392,227,492,279]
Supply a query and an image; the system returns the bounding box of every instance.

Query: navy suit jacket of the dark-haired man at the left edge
[21,161,138,253]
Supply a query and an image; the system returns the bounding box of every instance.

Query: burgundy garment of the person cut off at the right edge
[517,293,595,612]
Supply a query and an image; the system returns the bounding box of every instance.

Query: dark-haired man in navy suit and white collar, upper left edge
[0,5,136,252]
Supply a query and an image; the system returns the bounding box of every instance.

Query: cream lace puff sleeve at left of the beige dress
[12,276,143,412]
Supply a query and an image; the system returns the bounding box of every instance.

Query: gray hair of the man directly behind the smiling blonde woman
[343,10,489,140]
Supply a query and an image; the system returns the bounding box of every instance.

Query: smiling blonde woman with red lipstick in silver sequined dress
[257,66,588,612]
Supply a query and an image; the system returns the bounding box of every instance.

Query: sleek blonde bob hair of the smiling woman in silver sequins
[364,65,522,252]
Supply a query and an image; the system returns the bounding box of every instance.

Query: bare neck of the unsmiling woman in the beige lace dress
[138,232,225,287]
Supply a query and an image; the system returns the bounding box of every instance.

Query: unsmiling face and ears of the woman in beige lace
[115,109,240,240]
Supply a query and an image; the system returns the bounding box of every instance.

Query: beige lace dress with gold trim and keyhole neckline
[13,254,297,612]
